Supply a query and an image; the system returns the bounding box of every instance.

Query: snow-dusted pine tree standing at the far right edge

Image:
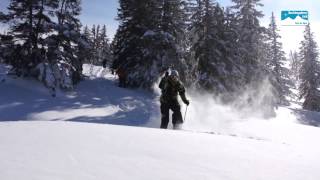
[299,25,320,111]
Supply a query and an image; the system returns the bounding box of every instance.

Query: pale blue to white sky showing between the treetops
[0,0,320,52]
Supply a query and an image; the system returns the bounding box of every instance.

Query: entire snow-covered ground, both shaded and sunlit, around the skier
[0,65,320,180]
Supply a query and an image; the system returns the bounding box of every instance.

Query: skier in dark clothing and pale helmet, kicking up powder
[159,70,190,129]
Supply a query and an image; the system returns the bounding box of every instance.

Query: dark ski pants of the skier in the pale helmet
[160,100,183,129]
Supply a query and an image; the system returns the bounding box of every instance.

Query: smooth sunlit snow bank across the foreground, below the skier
[0,122,320,180]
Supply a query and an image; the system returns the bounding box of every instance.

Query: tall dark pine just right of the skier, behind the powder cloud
[192,0,225,91]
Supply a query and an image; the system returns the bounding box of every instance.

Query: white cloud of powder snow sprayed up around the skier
[152,75,276,133]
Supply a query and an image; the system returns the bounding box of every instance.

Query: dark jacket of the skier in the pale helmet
[159,76,188,103]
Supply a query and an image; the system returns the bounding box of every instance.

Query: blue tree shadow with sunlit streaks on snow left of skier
[0,78,159,126]
